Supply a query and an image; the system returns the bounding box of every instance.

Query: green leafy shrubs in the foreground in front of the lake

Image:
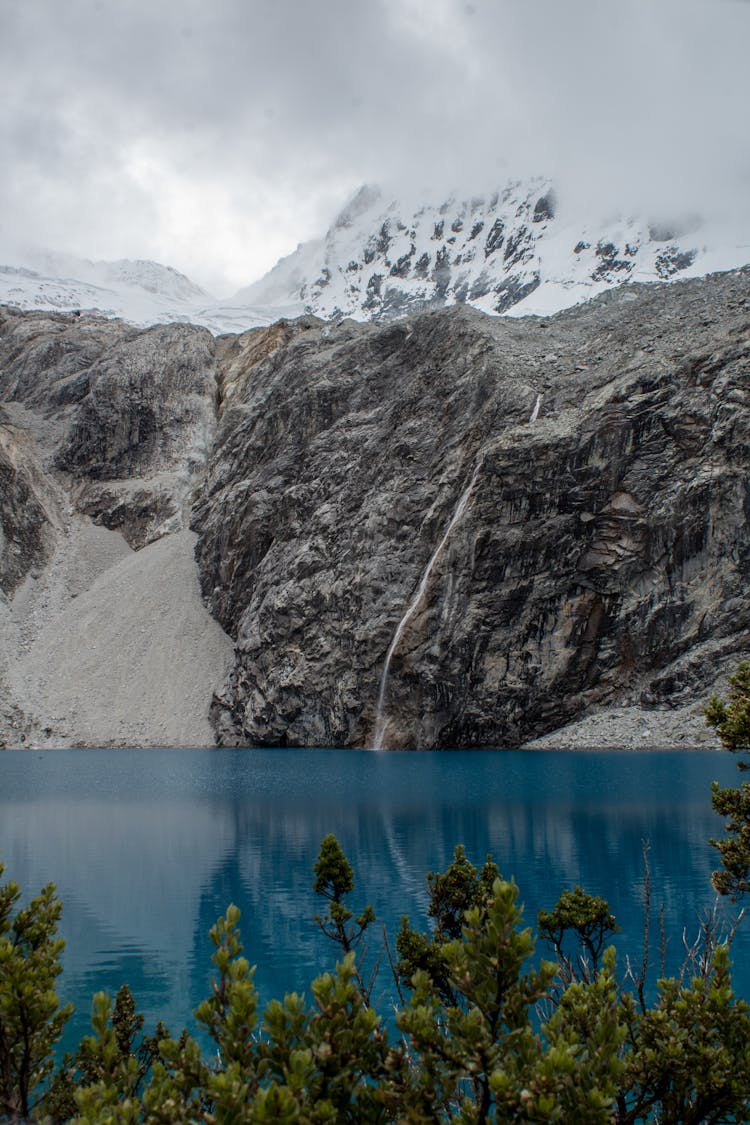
[0,664,750,1125]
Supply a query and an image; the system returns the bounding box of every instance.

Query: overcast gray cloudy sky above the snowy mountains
[0,0,750,295]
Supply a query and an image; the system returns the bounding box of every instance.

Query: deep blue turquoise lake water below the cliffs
[0,750,750,1043]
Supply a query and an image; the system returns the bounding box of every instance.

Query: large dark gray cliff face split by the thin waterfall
[195,271,750,747]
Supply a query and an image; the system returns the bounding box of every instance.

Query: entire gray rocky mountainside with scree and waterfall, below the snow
[0,265,750,749]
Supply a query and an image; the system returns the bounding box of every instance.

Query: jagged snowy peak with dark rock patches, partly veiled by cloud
[235,179,750,321]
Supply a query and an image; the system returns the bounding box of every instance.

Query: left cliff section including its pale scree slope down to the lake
[0,309,232,747]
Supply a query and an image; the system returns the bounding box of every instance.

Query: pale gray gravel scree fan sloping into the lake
[0,518,232,747]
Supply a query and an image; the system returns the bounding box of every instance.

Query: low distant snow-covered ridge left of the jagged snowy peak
[0,251,299,334]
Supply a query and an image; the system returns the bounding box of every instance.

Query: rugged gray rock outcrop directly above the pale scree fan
[0,309,216,548]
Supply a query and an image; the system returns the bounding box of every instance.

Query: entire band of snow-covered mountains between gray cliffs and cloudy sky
[0,178,750,334]
